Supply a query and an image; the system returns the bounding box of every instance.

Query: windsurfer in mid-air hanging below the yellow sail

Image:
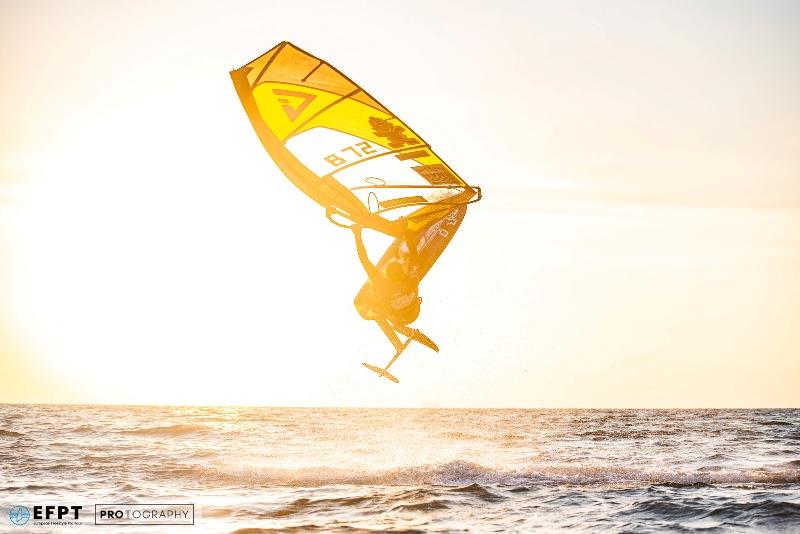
[351,224,439,356]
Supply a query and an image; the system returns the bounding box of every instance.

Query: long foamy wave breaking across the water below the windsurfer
[201,460,800,491]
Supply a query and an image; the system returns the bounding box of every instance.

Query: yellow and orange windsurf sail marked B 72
[231,42,480,237]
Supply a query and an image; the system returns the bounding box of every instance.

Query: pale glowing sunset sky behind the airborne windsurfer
[0,0,800,408]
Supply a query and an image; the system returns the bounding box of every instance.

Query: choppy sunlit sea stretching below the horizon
[0,404,800,534]
